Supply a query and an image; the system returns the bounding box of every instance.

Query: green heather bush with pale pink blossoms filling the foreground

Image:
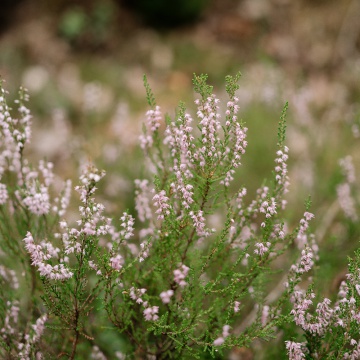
[0,74,360,359]
